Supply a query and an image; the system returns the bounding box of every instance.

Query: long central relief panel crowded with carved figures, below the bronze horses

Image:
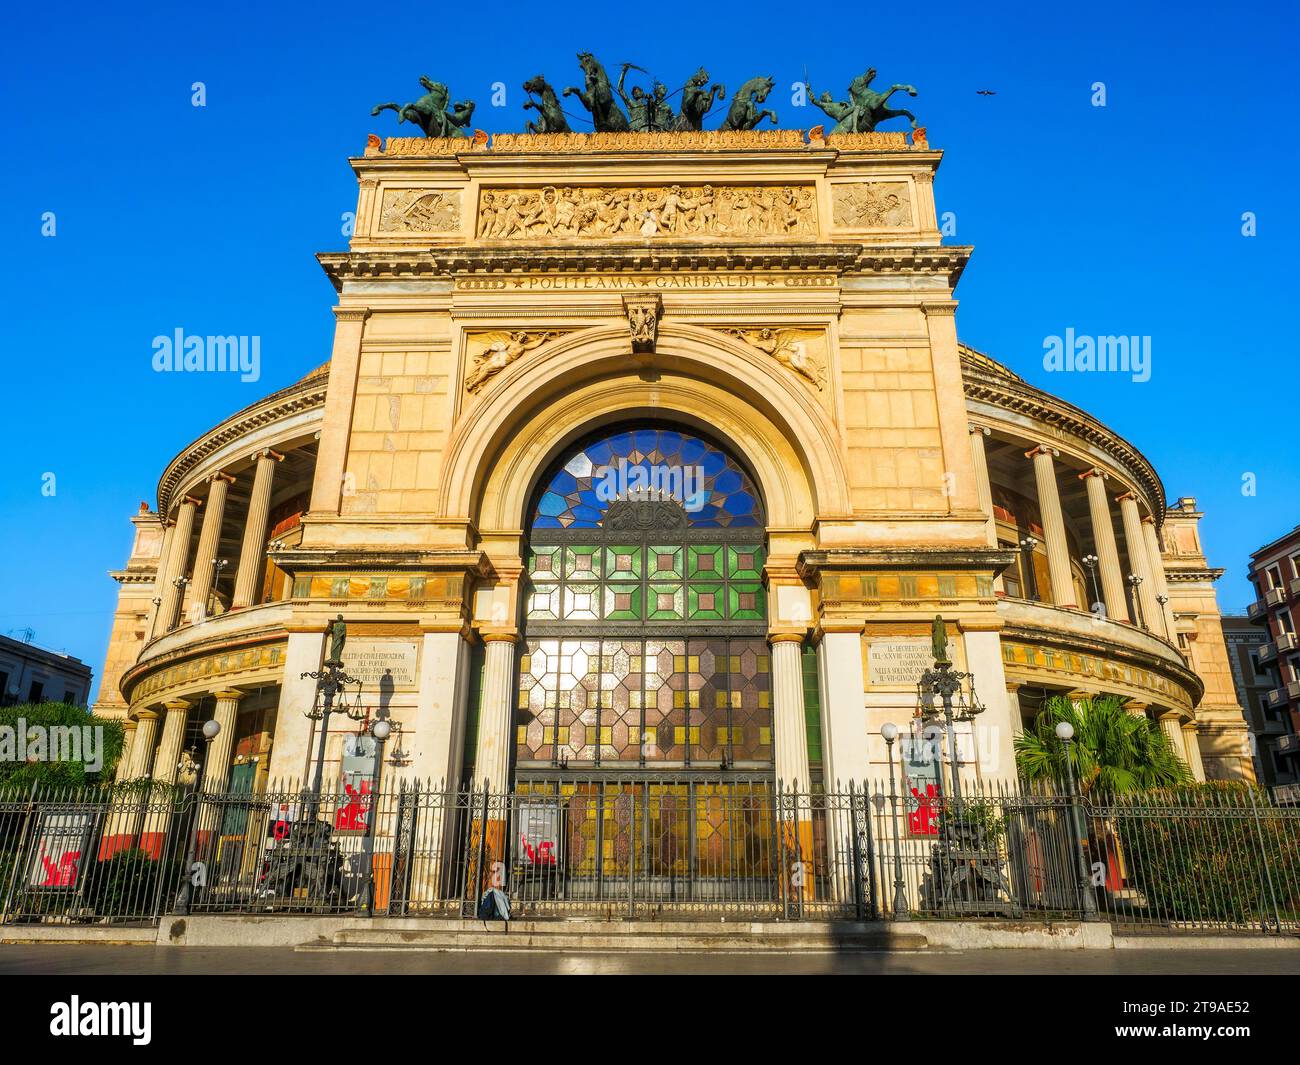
[476,185,818,241]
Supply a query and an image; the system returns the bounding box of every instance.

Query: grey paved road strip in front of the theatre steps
[0,944,1300,975]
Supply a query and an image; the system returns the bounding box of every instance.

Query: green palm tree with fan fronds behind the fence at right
[1015,696,1192,795]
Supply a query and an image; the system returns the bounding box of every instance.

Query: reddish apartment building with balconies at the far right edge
[1247,525,1300,779]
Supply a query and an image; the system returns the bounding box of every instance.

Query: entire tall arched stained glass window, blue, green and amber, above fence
[515,424,772,779]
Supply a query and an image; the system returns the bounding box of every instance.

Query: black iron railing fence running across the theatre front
[0,778,1300,932]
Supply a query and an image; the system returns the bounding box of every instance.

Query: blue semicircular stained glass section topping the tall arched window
[532,428,763,531]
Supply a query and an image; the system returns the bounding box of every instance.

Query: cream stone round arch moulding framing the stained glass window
[442,325,849,536]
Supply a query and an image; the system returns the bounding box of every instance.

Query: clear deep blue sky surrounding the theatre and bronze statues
[0,0,1300,696]
